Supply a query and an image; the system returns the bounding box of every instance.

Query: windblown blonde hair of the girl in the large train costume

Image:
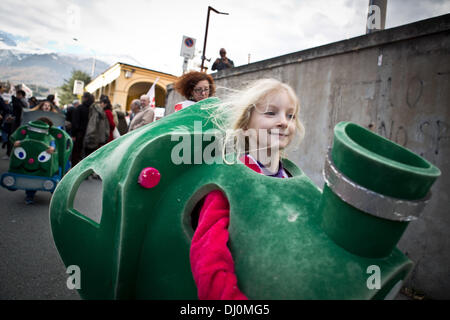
[205,79,305,161]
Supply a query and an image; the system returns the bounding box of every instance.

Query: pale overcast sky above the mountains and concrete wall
[0,0,450,75]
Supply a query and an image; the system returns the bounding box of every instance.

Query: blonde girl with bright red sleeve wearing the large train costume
[190,79,304,300]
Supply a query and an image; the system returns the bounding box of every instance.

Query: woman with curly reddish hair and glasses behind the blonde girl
[175,71,216,111]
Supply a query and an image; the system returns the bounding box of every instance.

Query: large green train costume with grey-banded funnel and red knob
[50,99,440,299]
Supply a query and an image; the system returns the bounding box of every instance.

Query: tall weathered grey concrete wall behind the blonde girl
[166,14,450,299]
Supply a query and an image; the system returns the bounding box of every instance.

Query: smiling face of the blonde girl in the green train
[247,90,297,153]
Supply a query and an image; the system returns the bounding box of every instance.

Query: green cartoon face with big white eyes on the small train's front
[10,139,58,177]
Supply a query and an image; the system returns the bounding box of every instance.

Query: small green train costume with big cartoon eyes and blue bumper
[0,111,73,192]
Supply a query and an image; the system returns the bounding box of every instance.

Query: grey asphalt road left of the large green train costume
[0,149,80,300]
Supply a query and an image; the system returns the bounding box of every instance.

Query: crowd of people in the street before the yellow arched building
[0,85,154,166]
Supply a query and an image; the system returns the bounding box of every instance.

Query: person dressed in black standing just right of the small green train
[71,92,94,166]
